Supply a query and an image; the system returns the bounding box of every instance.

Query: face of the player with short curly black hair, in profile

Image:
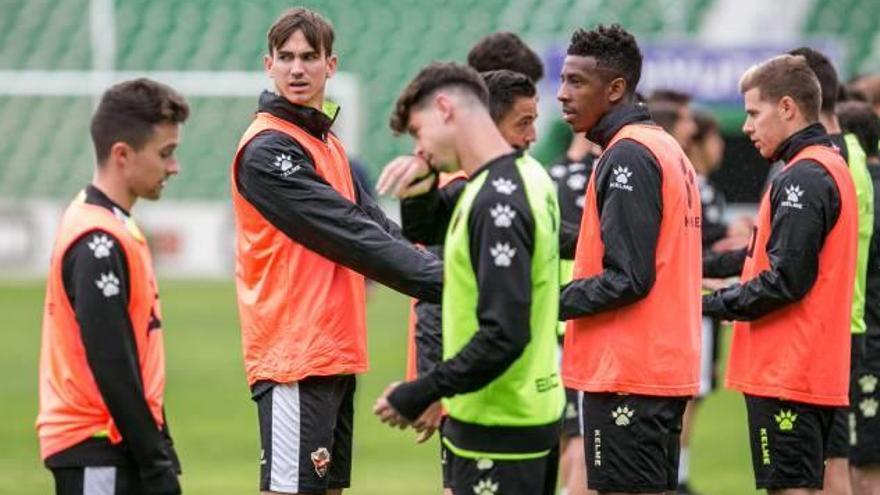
[556,55,611,132]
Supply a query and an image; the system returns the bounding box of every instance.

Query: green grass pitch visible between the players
[0,282,754,495]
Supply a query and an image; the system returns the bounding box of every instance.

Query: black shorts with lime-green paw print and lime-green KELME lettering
[745,395,838,490]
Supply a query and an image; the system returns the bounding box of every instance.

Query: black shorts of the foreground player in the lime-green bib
[442,444,559,495]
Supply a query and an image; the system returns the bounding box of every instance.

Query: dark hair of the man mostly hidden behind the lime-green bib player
[467,31,544,82]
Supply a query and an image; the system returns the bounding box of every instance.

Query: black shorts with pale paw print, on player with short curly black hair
[581,392,688,492]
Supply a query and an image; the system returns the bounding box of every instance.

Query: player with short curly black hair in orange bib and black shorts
[557,25,701,494]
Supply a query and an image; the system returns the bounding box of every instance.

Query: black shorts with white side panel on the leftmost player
[52,466,146,495]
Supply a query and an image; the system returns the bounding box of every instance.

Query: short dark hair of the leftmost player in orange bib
[90,78,189,165]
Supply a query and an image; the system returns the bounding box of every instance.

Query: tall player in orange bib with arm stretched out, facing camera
[231,8,442,494]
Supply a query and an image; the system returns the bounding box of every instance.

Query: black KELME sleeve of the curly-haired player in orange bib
[559,140,663,321]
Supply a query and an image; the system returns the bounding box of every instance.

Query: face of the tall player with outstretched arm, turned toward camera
[263,31,337,110]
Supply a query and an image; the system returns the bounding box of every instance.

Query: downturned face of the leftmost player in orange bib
[124,123,180,200]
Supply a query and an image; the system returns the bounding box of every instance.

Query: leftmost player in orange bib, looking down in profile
[37,79,189,495]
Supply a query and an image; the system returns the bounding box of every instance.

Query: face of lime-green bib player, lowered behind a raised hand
[407,103,459,172]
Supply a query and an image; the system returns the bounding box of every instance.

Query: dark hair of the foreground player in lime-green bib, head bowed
[390,62,489,134]
